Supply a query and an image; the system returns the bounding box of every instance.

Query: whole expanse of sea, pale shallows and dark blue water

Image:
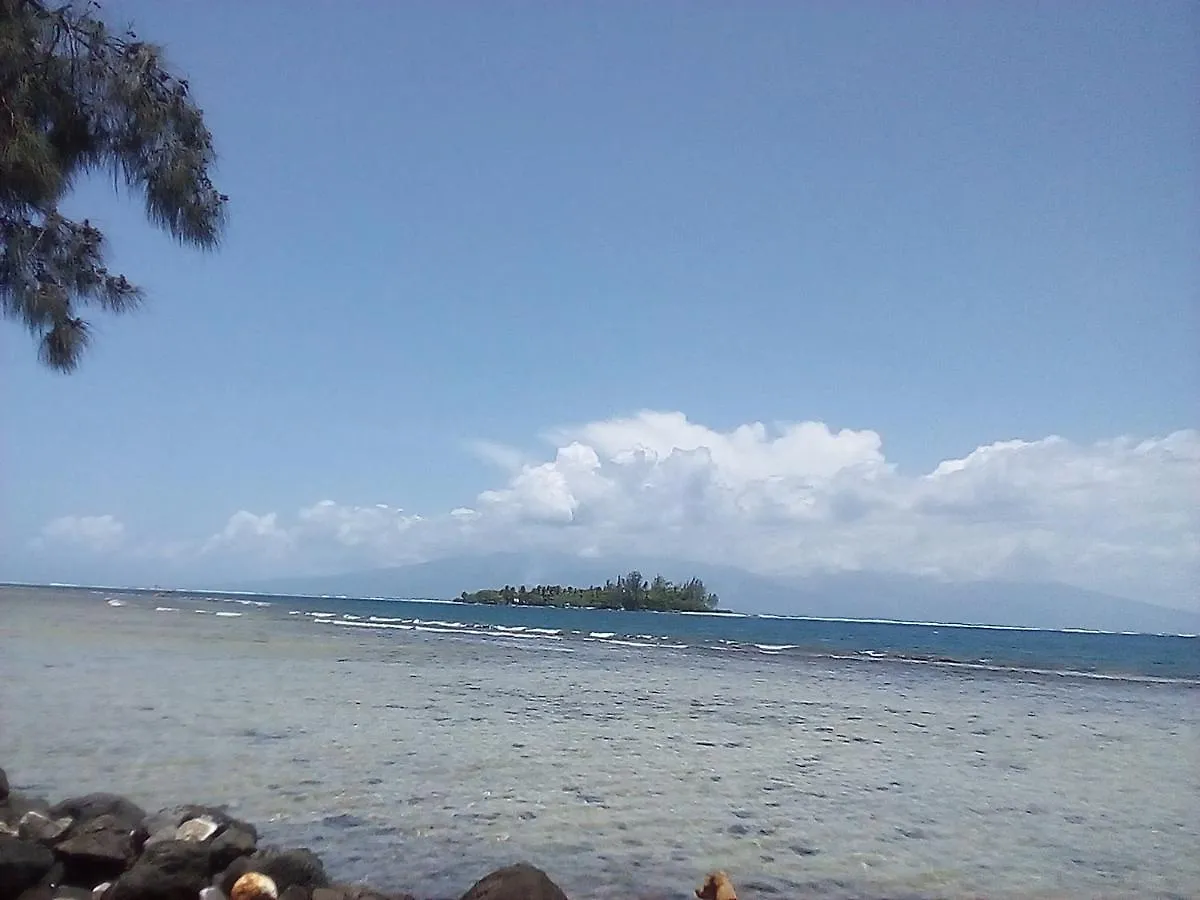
[0,588,1200,900]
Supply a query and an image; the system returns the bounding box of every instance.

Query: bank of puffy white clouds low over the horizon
[28,412,1200,608]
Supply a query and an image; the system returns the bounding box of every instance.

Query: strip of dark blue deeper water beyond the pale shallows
[154,585,1200,684]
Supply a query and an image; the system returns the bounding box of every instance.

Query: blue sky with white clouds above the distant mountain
[0,0,1200,610]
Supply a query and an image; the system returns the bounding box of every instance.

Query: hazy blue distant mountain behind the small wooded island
[236,553,1200,634]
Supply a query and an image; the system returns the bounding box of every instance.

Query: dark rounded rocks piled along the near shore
[0,769,619,900]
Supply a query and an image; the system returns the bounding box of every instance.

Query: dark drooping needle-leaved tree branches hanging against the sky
[0,0,228,372]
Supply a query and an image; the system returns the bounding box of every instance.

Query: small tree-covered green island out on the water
[458,571,720,612]
